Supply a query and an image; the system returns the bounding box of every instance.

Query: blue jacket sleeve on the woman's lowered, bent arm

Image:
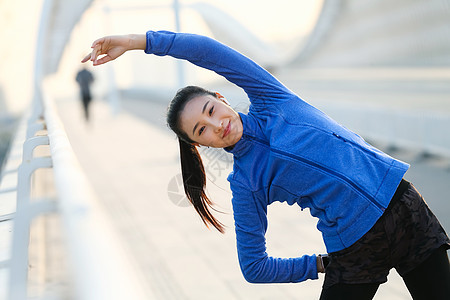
[232,182,318,283]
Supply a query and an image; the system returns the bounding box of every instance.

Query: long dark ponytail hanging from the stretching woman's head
[178,138,225,233]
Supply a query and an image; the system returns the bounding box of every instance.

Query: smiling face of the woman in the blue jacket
[180,95,243,148]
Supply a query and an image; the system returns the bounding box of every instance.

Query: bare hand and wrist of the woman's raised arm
[81,35,145,66]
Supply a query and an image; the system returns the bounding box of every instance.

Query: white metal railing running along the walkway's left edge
[0,83,153,300]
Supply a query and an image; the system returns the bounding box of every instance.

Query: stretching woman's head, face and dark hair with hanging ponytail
[163,86,243,232]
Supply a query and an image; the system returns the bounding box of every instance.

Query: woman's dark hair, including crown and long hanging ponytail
[167,86,225,233]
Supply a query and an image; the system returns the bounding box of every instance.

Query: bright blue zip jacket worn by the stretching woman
[145,31,409,283]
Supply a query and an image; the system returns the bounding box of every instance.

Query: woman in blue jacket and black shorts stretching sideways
[82,31,450,299]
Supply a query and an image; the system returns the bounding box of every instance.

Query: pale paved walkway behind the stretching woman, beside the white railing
[52,93,428,300]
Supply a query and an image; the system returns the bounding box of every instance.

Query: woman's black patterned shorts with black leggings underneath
[320,180,450,300]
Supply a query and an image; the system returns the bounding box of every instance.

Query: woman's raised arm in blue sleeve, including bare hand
[82,31,294,104]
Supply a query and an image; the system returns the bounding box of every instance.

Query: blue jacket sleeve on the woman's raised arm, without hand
[145,31,294,105]
